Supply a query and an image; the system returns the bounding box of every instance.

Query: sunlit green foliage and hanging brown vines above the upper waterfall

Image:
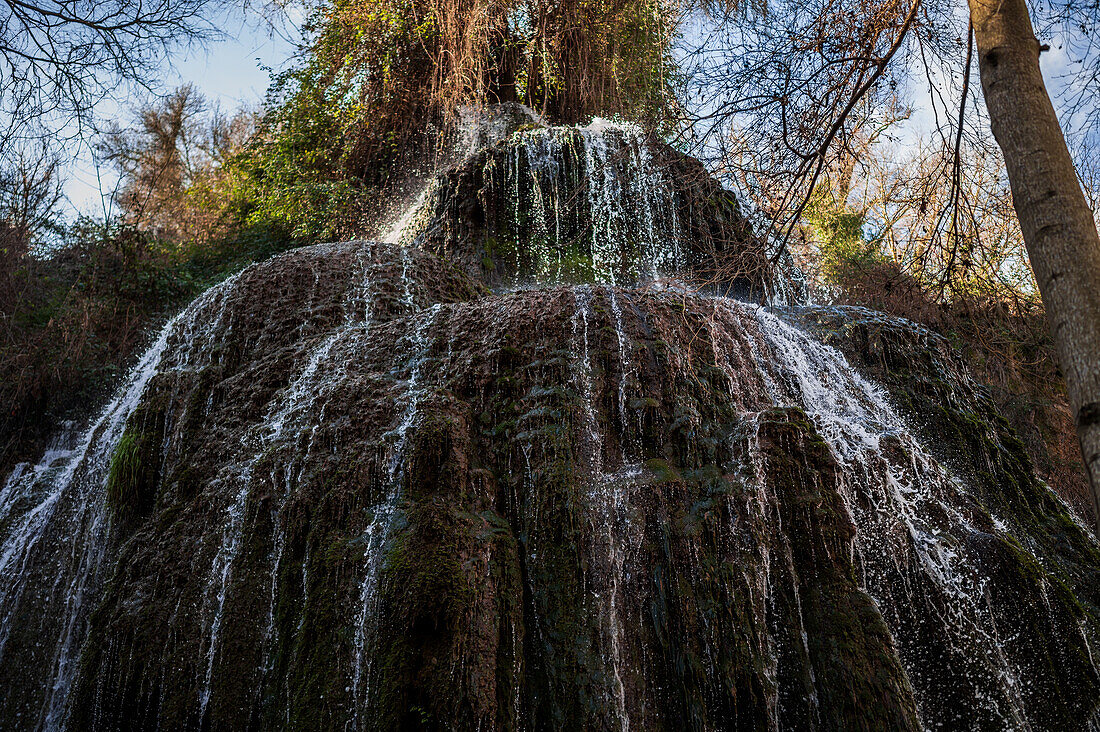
[215,0,673,243]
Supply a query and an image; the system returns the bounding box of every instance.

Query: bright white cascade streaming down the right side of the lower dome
[734,304,1026,729]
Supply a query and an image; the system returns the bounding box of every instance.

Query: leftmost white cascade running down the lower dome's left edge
[0,272,240,729]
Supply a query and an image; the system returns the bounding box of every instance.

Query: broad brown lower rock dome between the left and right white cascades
[58,244,916,729]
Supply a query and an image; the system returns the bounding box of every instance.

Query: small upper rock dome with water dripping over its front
[403,119,774,301]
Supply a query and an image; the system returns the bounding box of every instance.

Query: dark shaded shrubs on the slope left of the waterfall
[0,219,273,468]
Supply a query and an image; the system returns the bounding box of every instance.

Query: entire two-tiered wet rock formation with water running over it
[0,115,1100,730]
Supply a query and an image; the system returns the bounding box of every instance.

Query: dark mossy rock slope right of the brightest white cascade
[787,310,1100,729]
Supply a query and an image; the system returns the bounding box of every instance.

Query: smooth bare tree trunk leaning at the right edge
[968,0,1100,536]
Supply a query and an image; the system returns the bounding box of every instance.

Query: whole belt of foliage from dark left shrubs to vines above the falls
[0,0,672,465]
